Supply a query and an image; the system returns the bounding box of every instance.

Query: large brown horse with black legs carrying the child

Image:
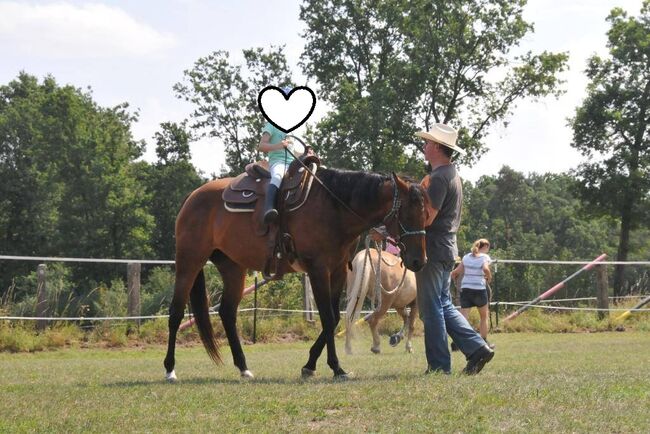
[164,169,430,381]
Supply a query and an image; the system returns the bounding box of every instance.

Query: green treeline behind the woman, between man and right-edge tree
[459,166,615,301]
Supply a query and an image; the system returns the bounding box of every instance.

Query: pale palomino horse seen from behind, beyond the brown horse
[345,249,418,354]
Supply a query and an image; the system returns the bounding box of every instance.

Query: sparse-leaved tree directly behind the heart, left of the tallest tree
[174,46,291,175]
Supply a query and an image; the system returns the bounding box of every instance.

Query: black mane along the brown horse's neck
[317,168,390,207]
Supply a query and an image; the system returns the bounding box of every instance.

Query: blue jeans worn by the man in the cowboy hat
[415,262,485,373]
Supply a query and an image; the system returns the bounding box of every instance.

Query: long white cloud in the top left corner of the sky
[0,2,177,59]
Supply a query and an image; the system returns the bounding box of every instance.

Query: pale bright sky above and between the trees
[0,0,642,181]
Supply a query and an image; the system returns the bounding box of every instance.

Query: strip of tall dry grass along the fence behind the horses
[0,302,650,352]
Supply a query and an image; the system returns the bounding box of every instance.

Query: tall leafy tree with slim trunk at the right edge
[571,0,650,296]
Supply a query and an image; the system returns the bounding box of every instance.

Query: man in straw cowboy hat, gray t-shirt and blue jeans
[415,124,494,375]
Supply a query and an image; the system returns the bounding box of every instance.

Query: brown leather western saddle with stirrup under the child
[222,146,320,280]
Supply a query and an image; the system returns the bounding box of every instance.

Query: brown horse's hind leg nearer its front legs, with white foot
[210,252,253,378]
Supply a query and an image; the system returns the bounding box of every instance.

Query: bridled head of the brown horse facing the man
[384,173,430,271]
